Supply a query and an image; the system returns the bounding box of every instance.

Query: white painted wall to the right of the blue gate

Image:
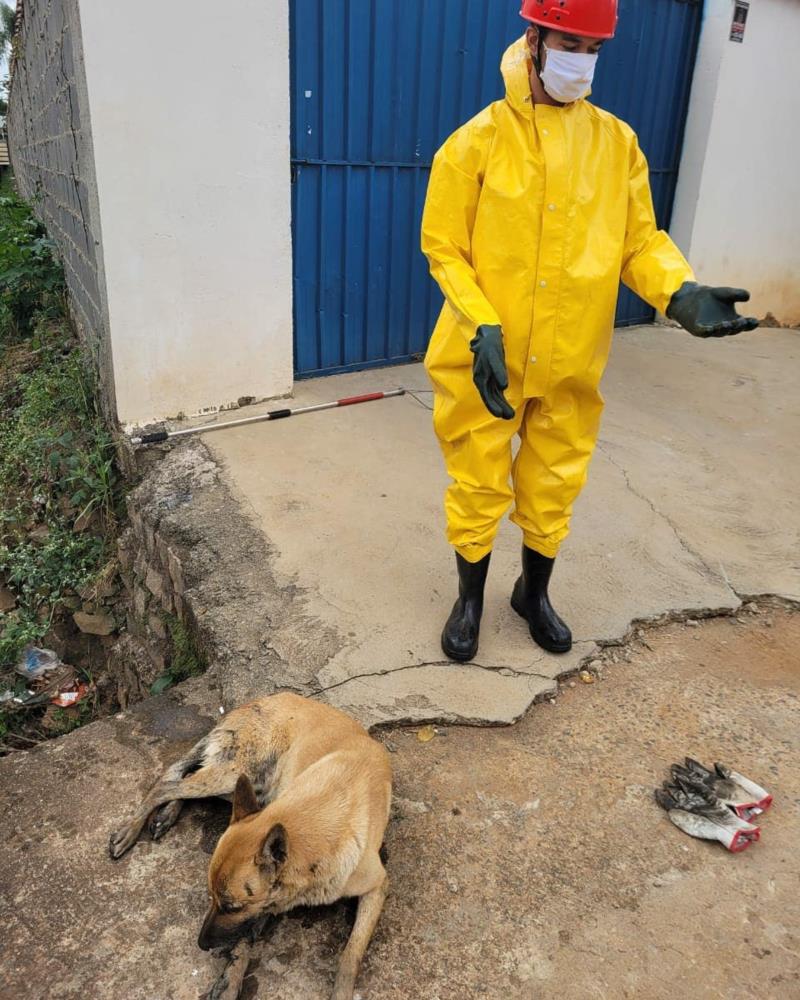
[671,0,800,324]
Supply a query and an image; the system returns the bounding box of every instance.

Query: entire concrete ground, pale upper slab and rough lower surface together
[0,329,800,1000]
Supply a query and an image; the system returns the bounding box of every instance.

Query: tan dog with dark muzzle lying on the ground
[109,693,392,1000]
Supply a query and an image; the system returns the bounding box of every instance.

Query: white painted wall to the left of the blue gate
[80,0,292,426]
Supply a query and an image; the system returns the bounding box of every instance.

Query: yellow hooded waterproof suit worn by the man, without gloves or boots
[422,38,694,562]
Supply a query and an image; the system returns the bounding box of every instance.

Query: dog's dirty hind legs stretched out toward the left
[108,731,239,860]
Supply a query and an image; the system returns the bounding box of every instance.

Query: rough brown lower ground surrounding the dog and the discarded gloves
[0,605,800,1000]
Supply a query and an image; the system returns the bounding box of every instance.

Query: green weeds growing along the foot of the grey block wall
[0,194,120,752]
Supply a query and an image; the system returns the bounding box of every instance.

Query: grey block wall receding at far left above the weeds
[8,0,116,420]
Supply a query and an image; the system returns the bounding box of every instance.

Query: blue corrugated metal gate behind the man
[291,0,702,376]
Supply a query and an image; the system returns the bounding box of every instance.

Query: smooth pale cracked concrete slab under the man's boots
[204,327,800,723]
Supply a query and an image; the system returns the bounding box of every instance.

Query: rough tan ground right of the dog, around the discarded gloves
[363,611,800,1000]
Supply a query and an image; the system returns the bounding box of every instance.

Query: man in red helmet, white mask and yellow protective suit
[422,0,758,661]
